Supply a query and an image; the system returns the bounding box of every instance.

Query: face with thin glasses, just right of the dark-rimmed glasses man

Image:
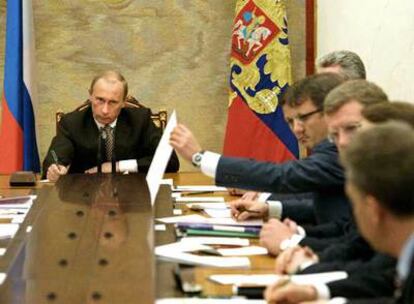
[325,101,363,152]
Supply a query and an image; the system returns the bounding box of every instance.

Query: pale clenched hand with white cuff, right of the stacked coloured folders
[260,219,294,255]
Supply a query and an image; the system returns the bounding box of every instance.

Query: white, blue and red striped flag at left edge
[0,0,40,173]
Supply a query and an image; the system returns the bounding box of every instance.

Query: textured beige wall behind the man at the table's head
[0,0,305,170]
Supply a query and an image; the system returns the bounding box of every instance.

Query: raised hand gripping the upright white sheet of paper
[170,124,202,162]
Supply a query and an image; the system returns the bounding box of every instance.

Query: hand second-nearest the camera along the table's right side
[275,246,319,274]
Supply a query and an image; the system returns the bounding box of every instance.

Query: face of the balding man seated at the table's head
[89,79,124,125]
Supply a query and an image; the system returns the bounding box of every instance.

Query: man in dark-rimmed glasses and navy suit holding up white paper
[170,73,349,233]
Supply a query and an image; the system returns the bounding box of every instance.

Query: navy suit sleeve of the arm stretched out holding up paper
[216,141,344,193]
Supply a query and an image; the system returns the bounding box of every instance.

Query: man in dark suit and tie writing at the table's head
[43,71,179,181]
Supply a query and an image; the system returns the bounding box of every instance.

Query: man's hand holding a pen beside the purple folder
[228,198,269,221]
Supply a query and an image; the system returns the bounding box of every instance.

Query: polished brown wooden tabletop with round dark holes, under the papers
[0,172,274,303]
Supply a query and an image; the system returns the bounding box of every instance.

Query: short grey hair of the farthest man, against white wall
[316,50,367,79]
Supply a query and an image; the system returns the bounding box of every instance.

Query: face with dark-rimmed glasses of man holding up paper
[283,99,327,149]
